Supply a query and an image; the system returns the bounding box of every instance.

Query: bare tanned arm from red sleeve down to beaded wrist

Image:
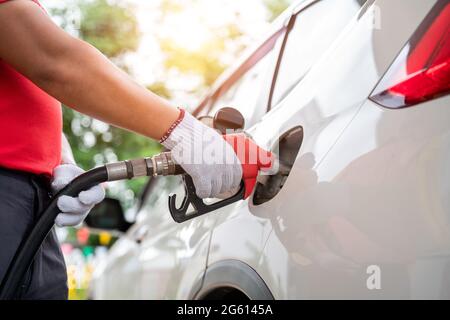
[0,0,179,139]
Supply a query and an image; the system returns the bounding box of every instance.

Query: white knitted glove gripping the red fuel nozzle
[161,111,242,198]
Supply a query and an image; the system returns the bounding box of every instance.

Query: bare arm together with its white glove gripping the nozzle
[0,0,270,202]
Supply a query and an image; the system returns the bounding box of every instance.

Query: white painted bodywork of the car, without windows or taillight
[90,0,450,299]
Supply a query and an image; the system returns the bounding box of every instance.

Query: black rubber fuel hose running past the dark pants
[0,166,108,300]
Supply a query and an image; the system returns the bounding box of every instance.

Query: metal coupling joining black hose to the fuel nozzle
[105,152,184,181]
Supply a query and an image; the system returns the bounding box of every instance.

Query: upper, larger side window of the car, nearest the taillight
[270,0,364,106]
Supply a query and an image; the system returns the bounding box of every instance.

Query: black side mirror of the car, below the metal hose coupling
[85,198,132,232]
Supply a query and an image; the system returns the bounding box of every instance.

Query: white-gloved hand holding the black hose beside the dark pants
[52,164,105,227]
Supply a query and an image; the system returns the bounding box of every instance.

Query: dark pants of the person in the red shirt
[0,168,68,299]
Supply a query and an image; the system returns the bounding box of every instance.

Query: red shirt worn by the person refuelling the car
[0,0,62,175]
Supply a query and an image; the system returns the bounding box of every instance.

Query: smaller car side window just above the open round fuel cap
[209,44,275,128]
